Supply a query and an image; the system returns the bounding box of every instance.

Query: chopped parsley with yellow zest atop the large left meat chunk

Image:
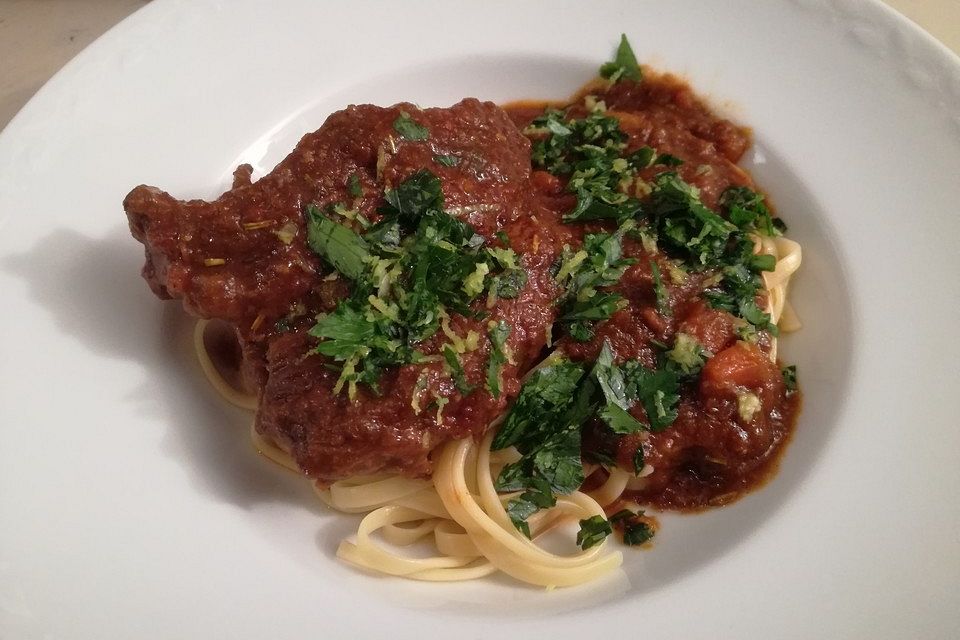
[306,170,526,402]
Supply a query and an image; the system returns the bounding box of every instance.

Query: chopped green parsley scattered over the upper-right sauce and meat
[524,40,786,341]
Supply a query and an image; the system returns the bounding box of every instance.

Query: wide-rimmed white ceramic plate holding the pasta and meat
[0,0,960,639]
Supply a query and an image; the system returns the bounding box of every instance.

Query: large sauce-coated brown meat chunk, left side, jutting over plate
[124,99,558,482]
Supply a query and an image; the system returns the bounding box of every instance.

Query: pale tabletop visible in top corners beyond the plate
[0,0,960,129]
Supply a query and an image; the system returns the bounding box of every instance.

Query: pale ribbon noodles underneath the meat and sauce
[194,230,801,587]
